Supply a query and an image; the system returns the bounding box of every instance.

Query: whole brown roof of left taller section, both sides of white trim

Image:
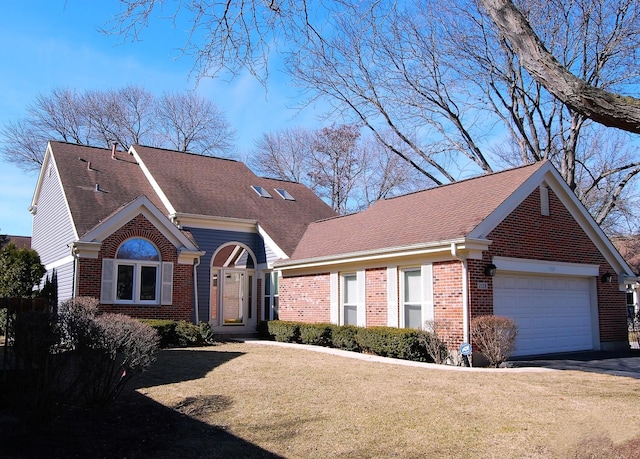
[50,142,336,254]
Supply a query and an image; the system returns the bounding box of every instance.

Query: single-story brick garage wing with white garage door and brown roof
[274,161,635,356]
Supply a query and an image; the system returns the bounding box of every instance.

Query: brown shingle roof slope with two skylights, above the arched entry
[133,145,335,254]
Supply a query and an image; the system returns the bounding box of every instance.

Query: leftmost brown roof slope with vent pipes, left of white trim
[50,141,166,236]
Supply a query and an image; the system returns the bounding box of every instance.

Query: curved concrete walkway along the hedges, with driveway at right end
[243,339,640,379]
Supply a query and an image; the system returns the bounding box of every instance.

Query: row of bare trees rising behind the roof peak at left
[0,86,234,171]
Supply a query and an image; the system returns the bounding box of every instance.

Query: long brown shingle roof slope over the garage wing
[291,162,545,261]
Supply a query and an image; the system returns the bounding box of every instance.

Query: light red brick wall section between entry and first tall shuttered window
[278,273,330,323]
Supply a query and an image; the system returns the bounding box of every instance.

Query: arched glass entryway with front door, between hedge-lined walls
[210,242,256,327]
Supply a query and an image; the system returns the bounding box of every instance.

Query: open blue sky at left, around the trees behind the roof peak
[0,0,328,235]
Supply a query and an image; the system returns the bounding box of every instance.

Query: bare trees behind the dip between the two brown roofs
[248,125,424,214]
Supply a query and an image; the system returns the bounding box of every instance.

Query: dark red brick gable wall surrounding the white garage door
[468,190,627,343]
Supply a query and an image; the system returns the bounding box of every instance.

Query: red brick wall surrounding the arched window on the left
[76,214,193,321]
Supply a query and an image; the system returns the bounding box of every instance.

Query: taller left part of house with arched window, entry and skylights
[30,142,335,334]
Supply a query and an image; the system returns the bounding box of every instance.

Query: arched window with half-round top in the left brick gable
[115,238,160,304]
